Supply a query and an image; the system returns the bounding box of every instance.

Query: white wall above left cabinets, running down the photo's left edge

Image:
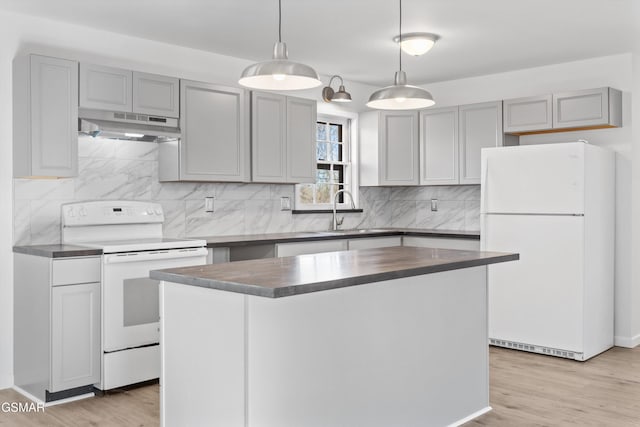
[0,12,373,389]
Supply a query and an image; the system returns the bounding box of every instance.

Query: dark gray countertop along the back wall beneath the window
[198,228,480,248]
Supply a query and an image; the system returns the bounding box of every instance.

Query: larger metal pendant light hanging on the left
[238,0,322,90]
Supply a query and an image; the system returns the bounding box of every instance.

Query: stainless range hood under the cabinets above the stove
[78,108,180,142]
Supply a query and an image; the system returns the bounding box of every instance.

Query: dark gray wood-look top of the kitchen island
[150,246,519,298]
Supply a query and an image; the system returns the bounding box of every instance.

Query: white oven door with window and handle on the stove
[102,248,207,352]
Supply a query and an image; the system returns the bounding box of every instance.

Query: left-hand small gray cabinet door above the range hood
[80,63,133,112]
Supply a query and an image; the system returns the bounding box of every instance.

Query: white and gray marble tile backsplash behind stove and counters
[13,137,480,245]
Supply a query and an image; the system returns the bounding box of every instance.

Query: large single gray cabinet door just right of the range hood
[179,80,249,182]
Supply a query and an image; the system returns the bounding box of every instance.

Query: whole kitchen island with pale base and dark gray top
[151,247,518,427]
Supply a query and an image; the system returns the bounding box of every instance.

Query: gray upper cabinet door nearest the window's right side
[378,111,420,185]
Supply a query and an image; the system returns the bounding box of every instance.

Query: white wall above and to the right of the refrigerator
[425,53,640,347]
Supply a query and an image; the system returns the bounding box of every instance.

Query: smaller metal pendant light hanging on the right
[367,0,435,110]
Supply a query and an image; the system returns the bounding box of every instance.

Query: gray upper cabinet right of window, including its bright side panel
[360,111,420,186]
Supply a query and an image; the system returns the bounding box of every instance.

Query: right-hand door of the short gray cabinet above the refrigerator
[553,87,609,128]
